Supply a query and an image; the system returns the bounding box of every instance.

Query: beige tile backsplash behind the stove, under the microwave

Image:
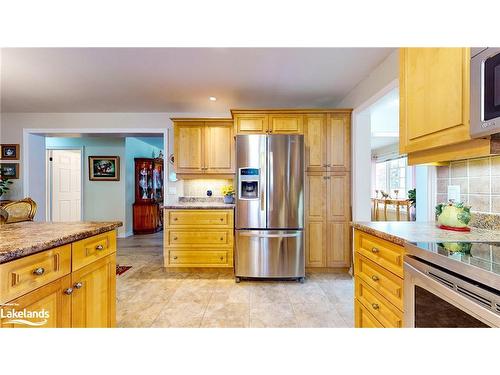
[437,156,500,214]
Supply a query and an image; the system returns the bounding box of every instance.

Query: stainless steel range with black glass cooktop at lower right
[404,242,500,328]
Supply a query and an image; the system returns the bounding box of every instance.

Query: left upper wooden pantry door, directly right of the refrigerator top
[305,114,327,171]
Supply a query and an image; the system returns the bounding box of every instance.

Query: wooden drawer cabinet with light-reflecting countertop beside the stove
[351,222,500,328]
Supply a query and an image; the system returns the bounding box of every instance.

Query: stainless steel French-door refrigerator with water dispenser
[235,135,305,282]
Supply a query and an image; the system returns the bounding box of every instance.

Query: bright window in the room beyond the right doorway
[373,157,413,198]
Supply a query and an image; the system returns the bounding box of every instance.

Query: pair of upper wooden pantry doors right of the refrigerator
[305,111,351,172]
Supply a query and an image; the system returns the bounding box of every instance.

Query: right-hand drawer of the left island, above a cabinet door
[71,231,116,271]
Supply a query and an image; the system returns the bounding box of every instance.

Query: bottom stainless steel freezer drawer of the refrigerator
[235,230,305,278]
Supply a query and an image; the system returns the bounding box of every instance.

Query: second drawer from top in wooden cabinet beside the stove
[354,253,403,311]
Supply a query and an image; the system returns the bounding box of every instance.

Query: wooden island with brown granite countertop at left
[0,222,122,328]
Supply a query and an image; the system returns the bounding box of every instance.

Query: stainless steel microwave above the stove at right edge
[470,47,500,138]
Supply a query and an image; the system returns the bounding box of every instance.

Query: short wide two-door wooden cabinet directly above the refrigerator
[231,110,304,134]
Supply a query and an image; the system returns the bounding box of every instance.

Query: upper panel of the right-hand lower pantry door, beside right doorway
[327,173,351,221]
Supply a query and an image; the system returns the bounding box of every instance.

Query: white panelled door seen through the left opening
[49,150,82,221]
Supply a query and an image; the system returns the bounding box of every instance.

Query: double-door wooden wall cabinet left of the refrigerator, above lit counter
[172,119,235,175]
